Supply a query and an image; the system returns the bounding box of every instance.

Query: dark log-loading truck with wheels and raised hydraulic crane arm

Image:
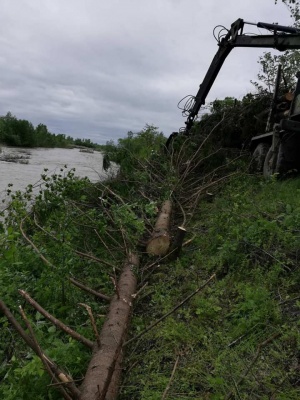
[166,19,300,176]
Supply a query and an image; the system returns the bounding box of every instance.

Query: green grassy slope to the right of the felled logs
[120,175,300,400]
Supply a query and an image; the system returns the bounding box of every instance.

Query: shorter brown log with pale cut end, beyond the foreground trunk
[146,200,172,256]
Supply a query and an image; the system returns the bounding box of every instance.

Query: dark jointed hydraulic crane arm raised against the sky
[166,19,300,148]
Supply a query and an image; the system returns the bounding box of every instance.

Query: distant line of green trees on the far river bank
[0,112,97,148]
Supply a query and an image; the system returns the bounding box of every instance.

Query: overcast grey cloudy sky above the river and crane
[0,0,292,143]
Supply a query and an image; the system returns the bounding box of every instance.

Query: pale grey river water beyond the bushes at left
[0,146,107,205]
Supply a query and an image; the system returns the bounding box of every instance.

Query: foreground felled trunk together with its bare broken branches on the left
[0,254,139,400]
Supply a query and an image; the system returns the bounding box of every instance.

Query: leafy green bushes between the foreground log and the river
[0,126,164,400]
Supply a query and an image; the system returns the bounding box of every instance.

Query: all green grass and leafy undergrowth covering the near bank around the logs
[0,120,300,400]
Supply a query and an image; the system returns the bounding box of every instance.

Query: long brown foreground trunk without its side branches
[80,255,139,400]
